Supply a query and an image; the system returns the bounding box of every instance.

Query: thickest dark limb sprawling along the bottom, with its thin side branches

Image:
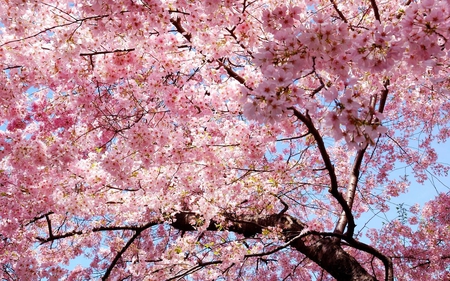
[33,212,382,281]
